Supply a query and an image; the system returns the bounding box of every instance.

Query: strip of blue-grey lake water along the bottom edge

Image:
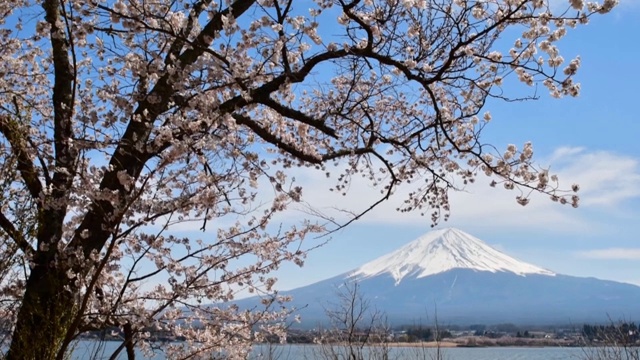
[67,341,589,360]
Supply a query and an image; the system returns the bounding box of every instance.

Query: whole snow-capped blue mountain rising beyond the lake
[232,229,640,327]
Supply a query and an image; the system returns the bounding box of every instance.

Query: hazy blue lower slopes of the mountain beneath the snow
[272,269,640,326]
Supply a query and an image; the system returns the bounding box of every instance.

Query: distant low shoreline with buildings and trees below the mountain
[76,322,640,347]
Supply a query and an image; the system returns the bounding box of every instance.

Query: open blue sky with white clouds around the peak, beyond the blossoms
[250,0,640,289]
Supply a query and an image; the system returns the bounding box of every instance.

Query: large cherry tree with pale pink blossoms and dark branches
[0,0,616,360]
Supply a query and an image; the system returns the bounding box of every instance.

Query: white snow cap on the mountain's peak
[349,228,555,284]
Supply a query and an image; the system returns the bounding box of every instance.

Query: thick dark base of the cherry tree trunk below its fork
[6,265,75,360]
